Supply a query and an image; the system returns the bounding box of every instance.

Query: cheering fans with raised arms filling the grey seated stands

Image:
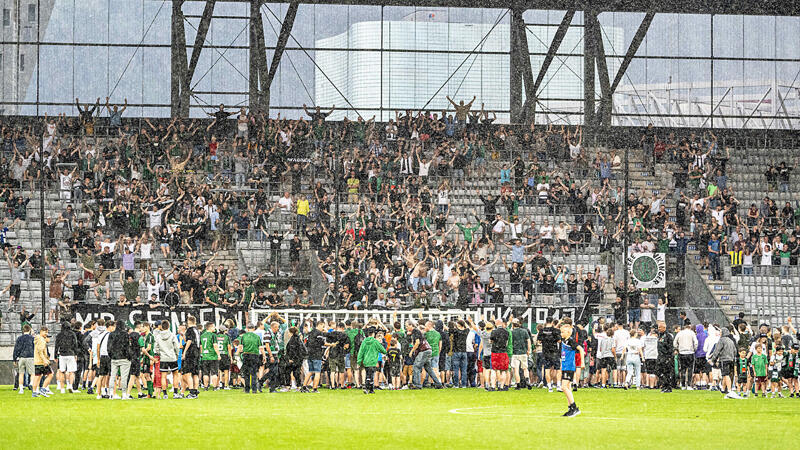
[0,99,800,326]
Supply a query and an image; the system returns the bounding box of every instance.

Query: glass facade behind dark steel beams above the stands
[0,0,800,128]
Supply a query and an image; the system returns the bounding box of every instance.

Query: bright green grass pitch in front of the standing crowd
[0,386,800,449]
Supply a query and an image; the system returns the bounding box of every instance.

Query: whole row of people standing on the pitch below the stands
[13,312,800,400]
